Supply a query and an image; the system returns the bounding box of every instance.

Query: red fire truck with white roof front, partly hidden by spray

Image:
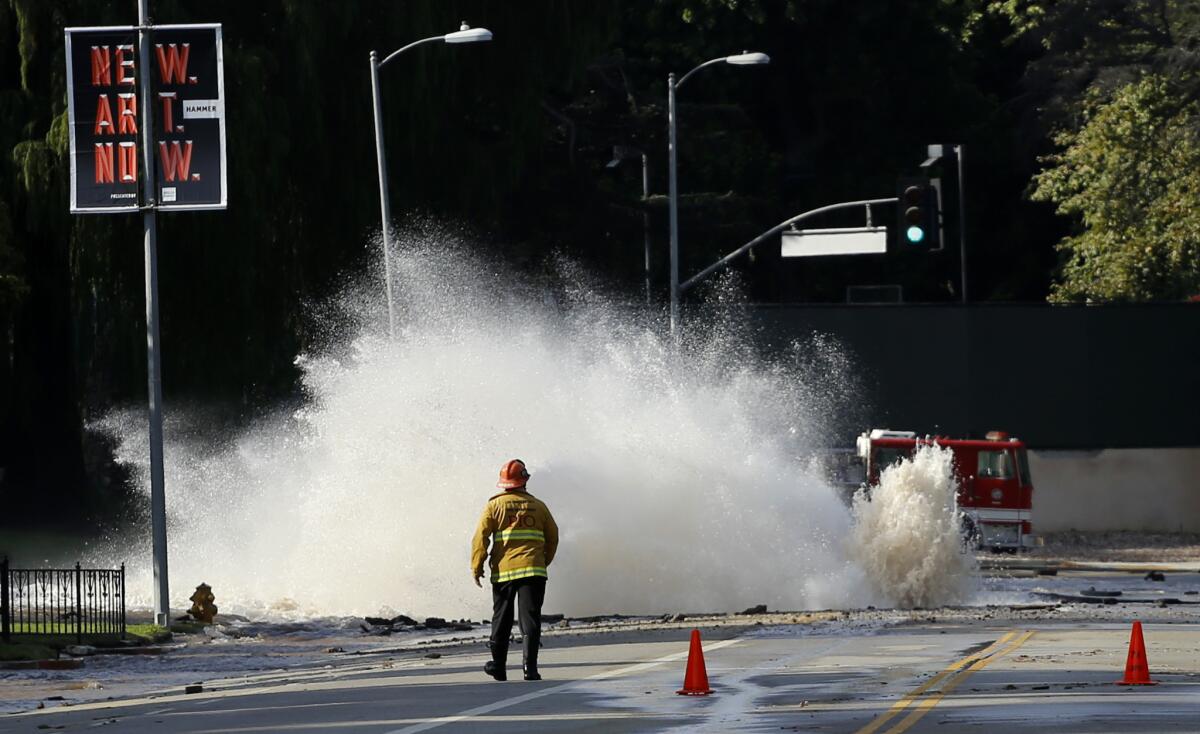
[858,428,1039,549]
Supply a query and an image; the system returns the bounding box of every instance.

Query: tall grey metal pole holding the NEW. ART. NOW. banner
[138,0,170,627]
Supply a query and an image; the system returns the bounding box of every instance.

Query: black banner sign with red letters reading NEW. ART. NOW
[66,24,228,212]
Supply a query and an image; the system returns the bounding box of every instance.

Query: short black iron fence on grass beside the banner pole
[0,558,125,642]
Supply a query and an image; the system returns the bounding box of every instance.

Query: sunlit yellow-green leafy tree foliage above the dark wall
[1033,74,1200,302]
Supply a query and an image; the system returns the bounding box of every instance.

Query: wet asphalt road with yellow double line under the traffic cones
[0,576,1200,734]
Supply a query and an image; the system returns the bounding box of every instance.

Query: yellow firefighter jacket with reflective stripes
[470,489,558,584]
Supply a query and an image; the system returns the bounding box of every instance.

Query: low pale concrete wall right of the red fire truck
[1030,449,1200,533]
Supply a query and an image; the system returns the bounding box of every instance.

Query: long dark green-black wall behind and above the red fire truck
[749,303,1200,450]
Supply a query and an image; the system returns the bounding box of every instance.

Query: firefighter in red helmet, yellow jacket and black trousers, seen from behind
[470,459,558,680]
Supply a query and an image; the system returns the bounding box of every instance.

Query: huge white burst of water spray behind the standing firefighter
[91,227,974,618]
